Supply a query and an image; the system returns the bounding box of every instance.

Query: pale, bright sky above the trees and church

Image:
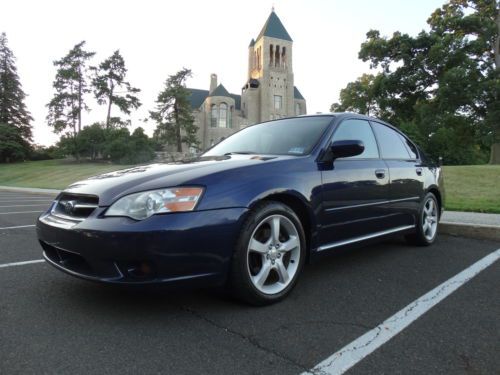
[0,0,444,145]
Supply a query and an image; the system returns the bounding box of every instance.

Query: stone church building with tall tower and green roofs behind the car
[189,10,306,150]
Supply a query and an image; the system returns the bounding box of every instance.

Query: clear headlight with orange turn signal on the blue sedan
[105,187,203,220]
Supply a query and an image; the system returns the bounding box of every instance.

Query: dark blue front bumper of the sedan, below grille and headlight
[37,208,247,285]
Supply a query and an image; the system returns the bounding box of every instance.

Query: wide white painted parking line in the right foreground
[302,249,500,375]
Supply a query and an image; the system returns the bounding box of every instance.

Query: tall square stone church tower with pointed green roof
[241,9,306,124]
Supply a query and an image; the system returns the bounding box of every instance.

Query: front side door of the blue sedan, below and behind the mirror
[320,119,389,250]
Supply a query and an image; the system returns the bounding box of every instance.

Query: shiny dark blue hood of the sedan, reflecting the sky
[64,155,286,206]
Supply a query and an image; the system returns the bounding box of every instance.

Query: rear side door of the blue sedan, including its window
[372,121,424,227]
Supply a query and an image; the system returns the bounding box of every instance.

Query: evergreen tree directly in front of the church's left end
[149,68,198,152]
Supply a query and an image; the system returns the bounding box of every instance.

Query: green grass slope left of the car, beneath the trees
[0,160,130,189]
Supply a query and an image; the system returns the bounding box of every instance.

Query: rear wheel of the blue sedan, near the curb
[406,193,439,246]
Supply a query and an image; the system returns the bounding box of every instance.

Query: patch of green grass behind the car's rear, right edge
[444,165,500,213]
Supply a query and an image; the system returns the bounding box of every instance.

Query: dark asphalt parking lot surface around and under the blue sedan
[0,191,500,374]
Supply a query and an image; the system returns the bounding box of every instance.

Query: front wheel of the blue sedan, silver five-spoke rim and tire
[228,201,306,306]
